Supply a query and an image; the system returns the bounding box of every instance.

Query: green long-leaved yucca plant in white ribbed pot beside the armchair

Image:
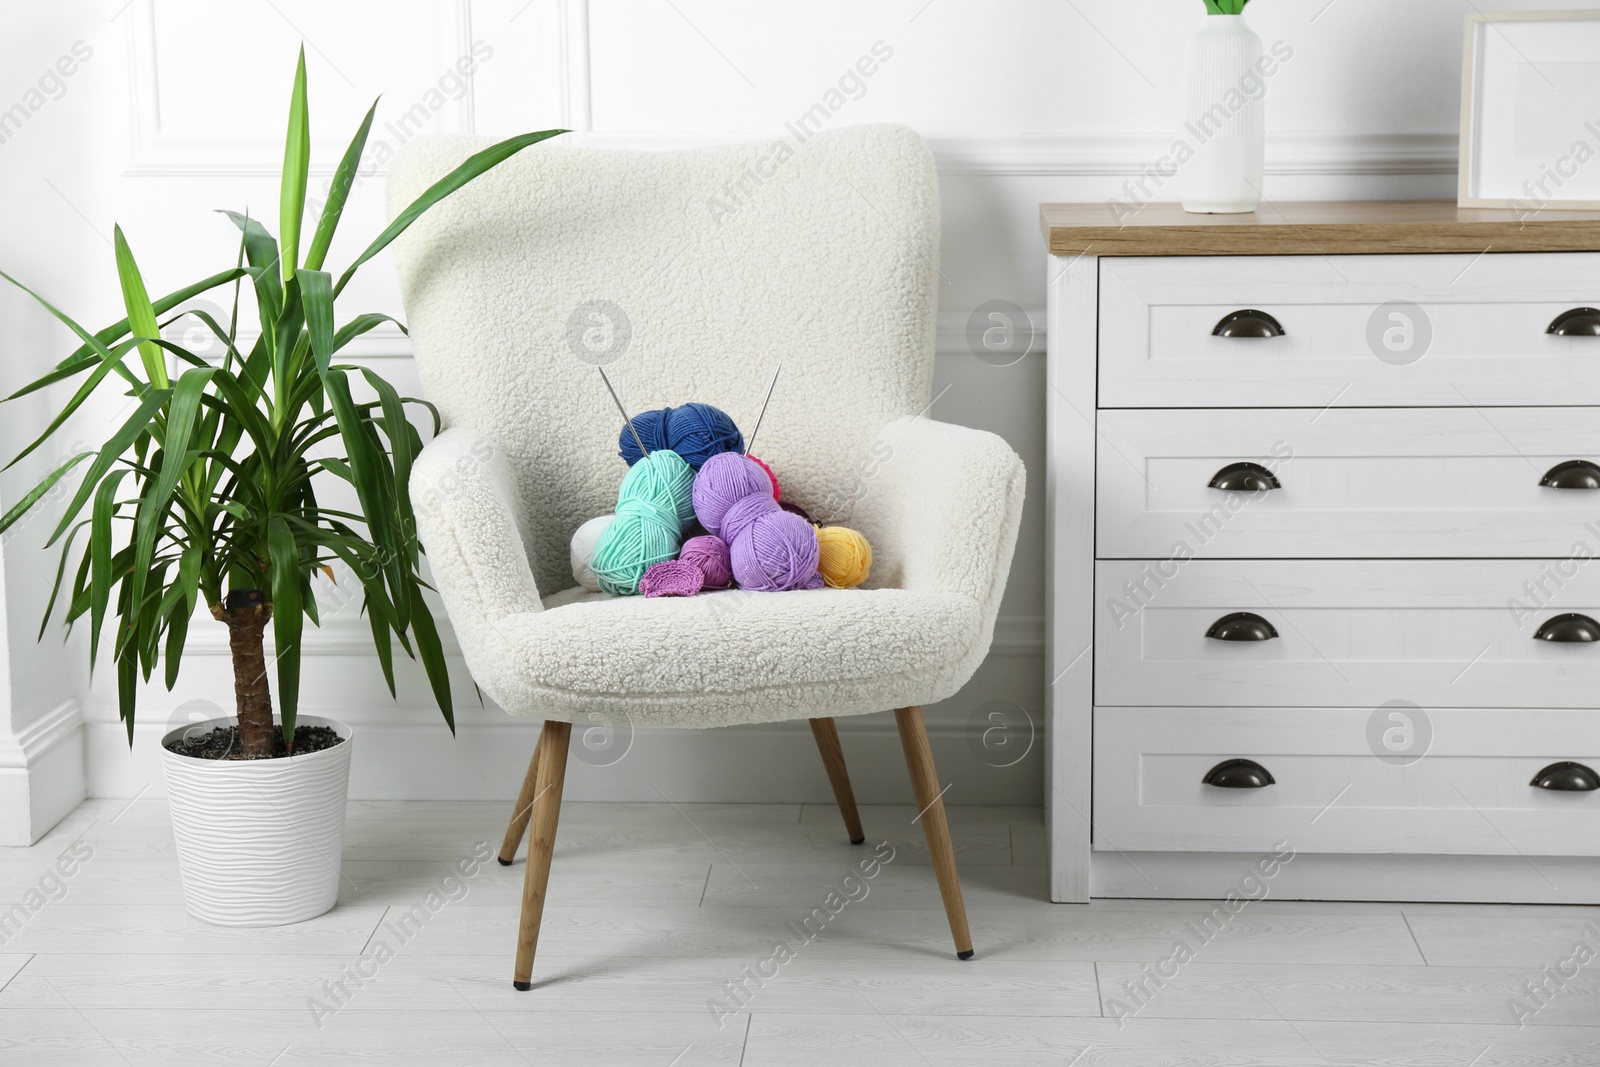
[0,50,562,925]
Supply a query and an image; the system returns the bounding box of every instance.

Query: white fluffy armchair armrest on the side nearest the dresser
[853,418,1026,622]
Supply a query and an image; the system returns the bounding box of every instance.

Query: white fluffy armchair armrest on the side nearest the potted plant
[411,426,541,630]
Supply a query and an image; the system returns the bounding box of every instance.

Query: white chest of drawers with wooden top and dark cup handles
[1042,202,1600,904]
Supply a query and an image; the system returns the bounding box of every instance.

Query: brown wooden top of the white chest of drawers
[1038,200,1600,256]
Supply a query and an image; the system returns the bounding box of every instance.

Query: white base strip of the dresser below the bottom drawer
[1090,848,1600,904]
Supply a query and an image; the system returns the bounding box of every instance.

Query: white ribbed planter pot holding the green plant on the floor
[162,715,350,926]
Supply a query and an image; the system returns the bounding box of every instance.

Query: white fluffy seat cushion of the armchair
[493,589,990,728]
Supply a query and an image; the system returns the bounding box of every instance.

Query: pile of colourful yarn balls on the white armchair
[571,403,872,597]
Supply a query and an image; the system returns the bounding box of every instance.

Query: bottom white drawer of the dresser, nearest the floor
[1094,707,1600,856]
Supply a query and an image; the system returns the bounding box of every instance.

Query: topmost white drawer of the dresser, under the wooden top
[1099,253,1600,408]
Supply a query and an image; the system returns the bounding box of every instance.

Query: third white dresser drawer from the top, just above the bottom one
[1094,560,1600,710]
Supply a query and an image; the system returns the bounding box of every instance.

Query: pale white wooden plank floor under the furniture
[0,800,1600,1067]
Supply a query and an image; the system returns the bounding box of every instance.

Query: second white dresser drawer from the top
[1096,406,1600,558]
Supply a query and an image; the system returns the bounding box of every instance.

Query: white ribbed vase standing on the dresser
[1182,14,1266,214]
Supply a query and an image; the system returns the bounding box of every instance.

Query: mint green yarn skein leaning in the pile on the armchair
[589,448,694,597]
